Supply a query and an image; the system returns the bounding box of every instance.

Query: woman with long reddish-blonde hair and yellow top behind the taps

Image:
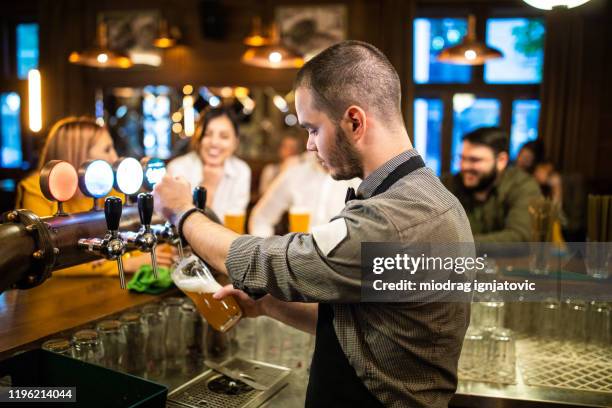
[16,117,172,275]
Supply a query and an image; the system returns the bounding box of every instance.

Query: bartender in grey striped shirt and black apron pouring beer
[155,41,473,407]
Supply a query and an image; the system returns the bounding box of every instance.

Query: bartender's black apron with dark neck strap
[305,156,425,408]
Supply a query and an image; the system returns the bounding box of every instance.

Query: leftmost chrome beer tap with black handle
[78,196,127,289]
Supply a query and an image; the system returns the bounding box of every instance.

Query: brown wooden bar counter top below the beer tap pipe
[0,277,179,359]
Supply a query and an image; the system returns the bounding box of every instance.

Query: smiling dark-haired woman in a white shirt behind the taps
[168,108,251,225]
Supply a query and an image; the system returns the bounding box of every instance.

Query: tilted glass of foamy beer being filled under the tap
[172,255,242,332]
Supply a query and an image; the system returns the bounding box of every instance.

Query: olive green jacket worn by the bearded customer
[442,167,542,242]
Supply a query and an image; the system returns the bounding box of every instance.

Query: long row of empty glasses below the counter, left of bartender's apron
[42,297,314,380]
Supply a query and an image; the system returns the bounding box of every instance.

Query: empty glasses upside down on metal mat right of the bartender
[459,297,612,383]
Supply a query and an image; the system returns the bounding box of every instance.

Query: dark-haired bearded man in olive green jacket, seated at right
[443,128,541,242]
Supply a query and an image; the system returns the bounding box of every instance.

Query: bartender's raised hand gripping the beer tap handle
[153,174,193,224]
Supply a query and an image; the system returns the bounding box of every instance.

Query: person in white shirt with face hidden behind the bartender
[249,152,361,238]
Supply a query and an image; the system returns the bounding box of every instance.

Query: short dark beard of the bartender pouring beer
[327,125,363,180]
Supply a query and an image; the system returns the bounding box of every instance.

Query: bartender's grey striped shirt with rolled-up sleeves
[226,149,473,407]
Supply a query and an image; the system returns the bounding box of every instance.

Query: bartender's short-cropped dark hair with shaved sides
[294,41,403,123]
